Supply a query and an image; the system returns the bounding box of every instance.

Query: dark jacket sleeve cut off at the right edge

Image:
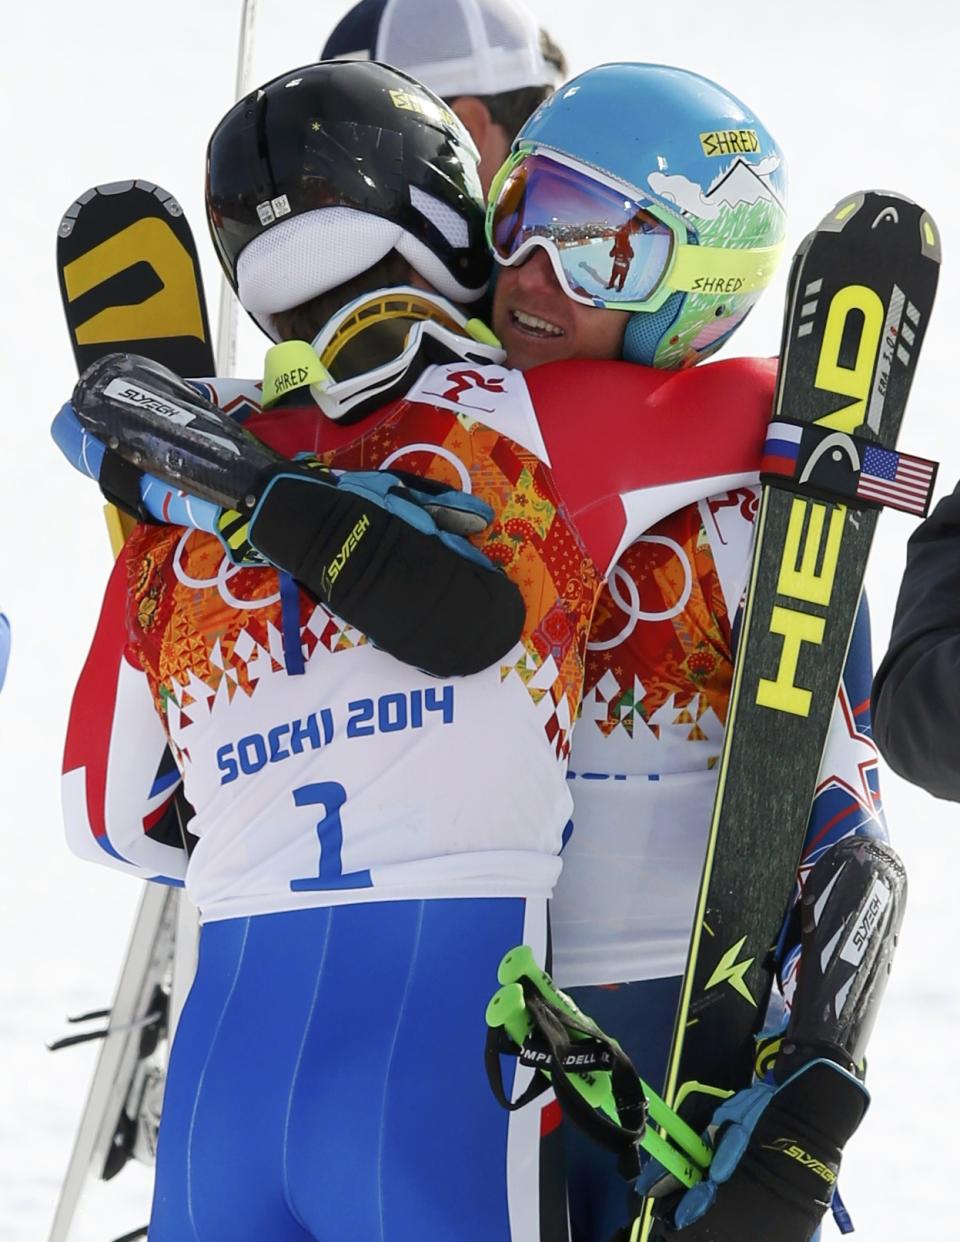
[873,484,960,802]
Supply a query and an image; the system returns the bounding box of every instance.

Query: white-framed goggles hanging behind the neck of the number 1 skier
[263,286,503,419]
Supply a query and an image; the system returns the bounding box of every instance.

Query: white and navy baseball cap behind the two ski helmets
[320,0,561,99]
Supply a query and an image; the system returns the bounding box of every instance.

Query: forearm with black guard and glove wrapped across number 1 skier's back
[63,354,525,677]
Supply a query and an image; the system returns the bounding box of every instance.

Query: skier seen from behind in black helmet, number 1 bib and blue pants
[56,62,774,1242]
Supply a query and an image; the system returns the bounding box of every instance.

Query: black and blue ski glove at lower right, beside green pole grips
[636,1061,869,1242]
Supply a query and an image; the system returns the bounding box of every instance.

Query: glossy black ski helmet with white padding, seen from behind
[206,61,491,327]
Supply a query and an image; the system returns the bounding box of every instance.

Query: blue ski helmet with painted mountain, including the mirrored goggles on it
[487,63,786,368]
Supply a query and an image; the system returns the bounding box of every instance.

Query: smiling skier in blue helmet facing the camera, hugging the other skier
[488,66,898,1242]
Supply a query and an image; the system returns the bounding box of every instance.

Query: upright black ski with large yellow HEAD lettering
[631,193,940,1242]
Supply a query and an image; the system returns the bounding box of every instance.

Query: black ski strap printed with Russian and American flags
[760,419,938,518]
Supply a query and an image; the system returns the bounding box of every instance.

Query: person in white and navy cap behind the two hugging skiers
[320,0,566,195]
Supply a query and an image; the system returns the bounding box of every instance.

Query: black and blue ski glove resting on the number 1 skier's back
[247,462,525,677]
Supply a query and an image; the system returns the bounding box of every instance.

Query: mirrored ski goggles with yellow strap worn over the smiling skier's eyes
[487,148,782,311]
